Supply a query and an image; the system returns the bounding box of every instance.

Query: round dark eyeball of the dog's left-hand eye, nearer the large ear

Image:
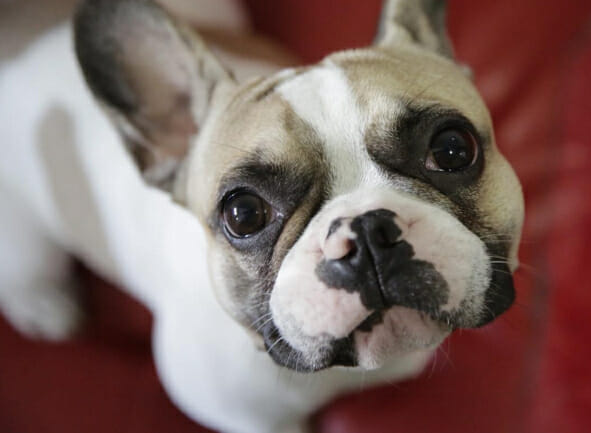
[224,193,267,237]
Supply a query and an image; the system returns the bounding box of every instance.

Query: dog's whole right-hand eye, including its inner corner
[425,128,478,171]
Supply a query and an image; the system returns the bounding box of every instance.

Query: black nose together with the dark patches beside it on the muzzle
[316,209,449,315]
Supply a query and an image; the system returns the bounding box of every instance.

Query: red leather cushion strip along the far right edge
[531,26,591,433]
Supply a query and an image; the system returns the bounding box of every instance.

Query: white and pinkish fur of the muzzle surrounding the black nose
[270,187,491,368]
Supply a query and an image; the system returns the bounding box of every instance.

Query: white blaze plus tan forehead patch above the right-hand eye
[274,49,490,194]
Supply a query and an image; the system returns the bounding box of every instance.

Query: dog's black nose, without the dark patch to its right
[316,209,413,310]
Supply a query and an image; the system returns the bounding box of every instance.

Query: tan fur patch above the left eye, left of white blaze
[187,75,322,215]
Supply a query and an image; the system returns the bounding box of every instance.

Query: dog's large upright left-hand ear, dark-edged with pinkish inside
[74,0,234,189]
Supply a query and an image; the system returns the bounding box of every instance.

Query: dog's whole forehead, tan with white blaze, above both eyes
[195,49,498,213]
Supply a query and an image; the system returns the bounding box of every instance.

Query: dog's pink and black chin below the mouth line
[263,306,452,373]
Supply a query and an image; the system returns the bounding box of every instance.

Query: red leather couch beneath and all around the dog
[0,0,591,433]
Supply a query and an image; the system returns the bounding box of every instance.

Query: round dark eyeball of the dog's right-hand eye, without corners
[431,130,474,171]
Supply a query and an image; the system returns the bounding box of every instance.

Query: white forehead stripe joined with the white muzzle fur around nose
[270,60,491,368]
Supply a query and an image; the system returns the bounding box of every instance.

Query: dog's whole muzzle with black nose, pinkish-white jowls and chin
[261,205,513,372]
